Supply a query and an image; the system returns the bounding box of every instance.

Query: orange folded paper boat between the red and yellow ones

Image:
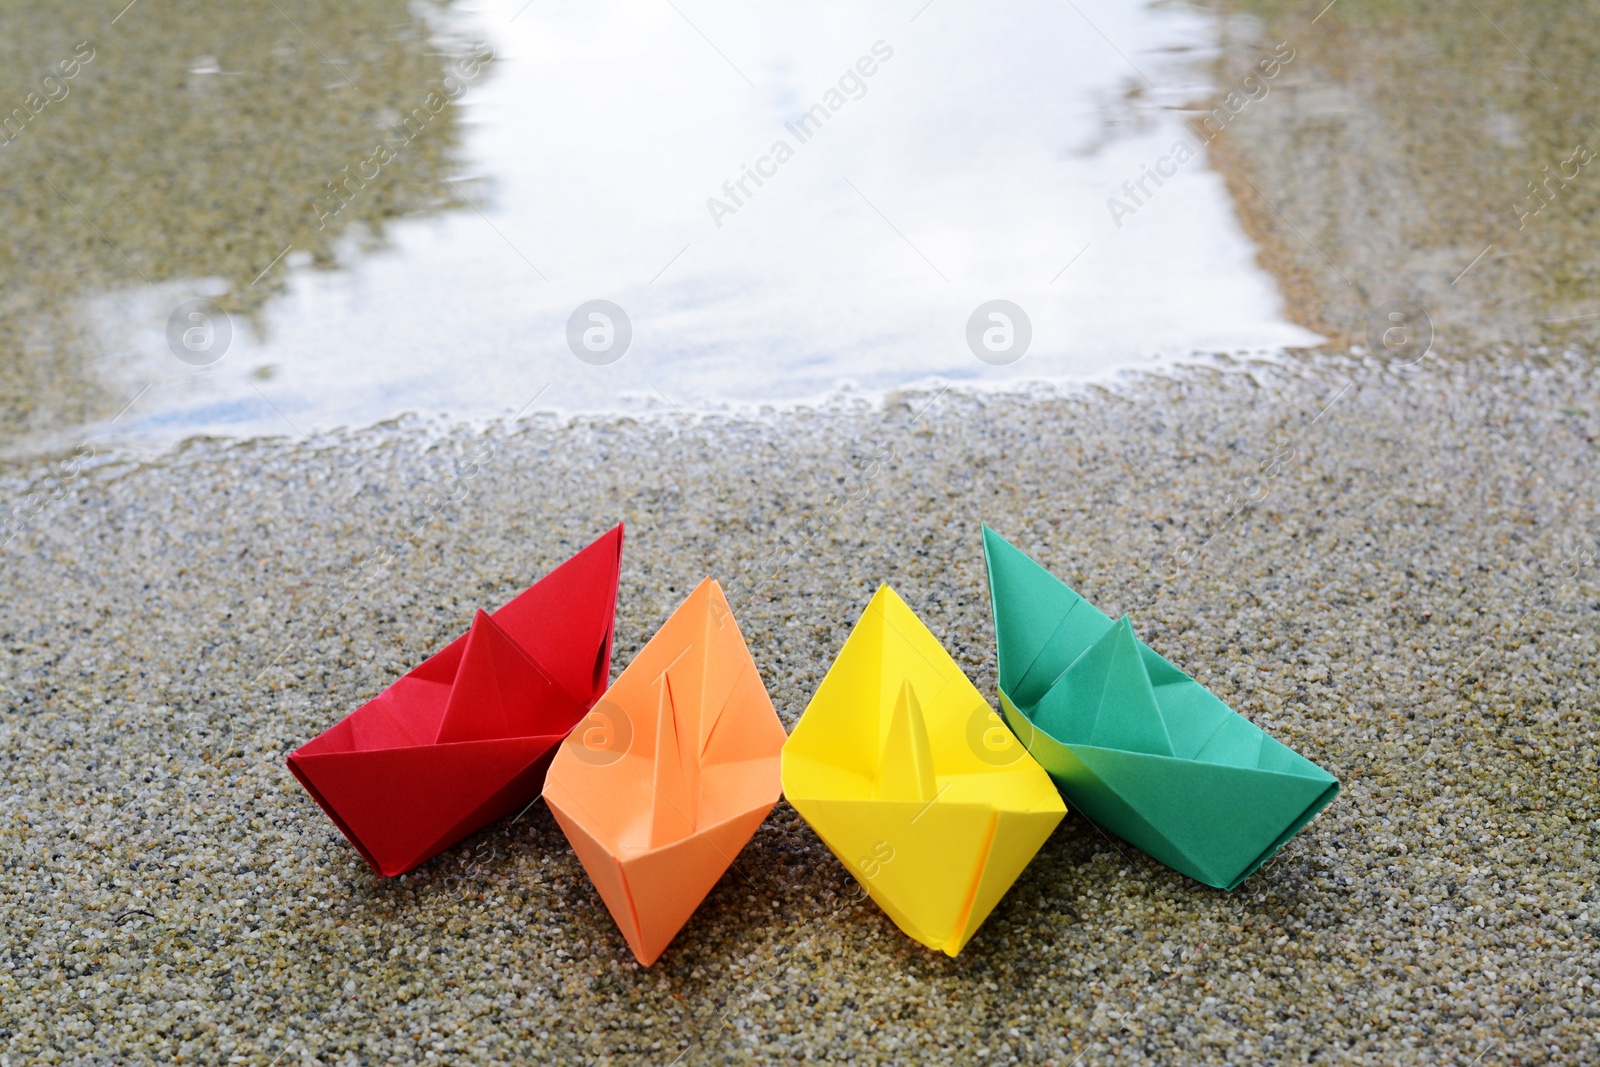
[544,577,784,966]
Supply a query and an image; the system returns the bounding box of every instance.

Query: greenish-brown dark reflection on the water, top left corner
[0,0,474,445]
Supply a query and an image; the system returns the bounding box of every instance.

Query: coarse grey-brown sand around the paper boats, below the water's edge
[0,354,1600,1064]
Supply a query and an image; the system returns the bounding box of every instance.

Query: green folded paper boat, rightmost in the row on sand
[984,526,1339,889]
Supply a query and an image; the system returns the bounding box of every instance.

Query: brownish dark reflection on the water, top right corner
[1214,0,1600,354]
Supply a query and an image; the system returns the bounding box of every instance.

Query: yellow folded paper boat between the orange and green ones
[784,585,1067,957]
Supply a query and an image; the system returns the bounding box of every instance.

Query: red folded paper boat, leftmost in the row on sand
[288,525,622,877]
